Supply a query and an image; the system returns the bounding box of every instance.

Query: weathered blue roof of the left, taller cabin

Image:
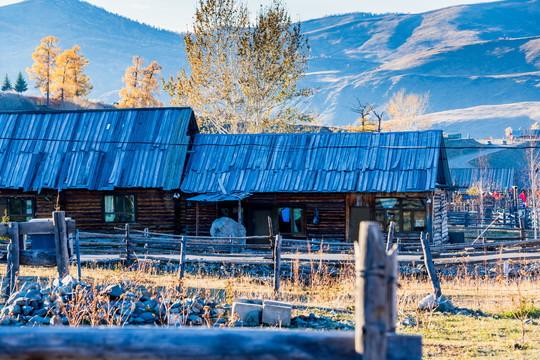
[0,108,197,191]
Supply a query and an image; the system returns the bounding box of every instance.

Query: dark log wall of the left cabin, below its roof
[0,188,185,233]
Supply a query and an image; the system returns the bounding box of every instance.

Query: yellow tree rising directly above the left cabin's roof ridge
[118,56,163,108]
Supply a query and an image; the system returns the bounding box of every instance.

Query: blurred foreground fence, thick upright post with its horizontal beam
[0,223,422,360]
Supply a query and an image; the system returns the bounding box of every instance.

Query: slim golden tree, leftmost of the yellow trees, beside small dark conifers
[26,36,60,107]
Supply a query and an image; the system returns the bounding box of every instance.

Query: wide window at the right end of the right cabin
[375,198,427,233]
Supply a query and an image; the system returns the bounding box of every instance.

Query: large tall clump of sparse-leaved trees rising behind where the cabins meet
[164,0,311,133]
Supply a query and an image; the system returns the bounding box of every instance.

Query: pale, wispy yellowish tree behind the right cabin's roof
[384,89,431,131]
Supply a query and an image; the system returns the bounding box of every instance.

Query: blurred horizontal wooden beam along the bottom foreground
[0,327,422,360]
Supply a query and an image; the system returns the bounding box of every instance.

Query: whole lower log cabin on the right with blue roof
[181,131,452,243]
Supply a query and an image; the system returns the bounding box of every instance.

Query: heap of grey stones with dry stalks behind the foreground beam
[0,275,231,326]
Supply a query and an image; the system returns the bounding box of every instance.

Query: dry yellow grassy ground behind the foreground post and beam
[0,265,540,359]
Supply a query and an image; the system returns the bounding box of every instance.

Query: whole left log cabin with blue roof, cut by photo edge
[0,108,198,232]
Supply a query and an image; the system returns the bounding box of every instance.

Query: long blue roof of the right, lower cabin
[181,131,450,193]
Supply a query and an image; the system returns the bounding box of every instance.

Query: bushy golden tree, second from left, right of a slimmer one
[51,45,92,101]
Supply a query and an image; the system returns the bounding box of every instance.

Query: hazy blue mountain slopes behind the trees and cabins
[0,0,540,137]
